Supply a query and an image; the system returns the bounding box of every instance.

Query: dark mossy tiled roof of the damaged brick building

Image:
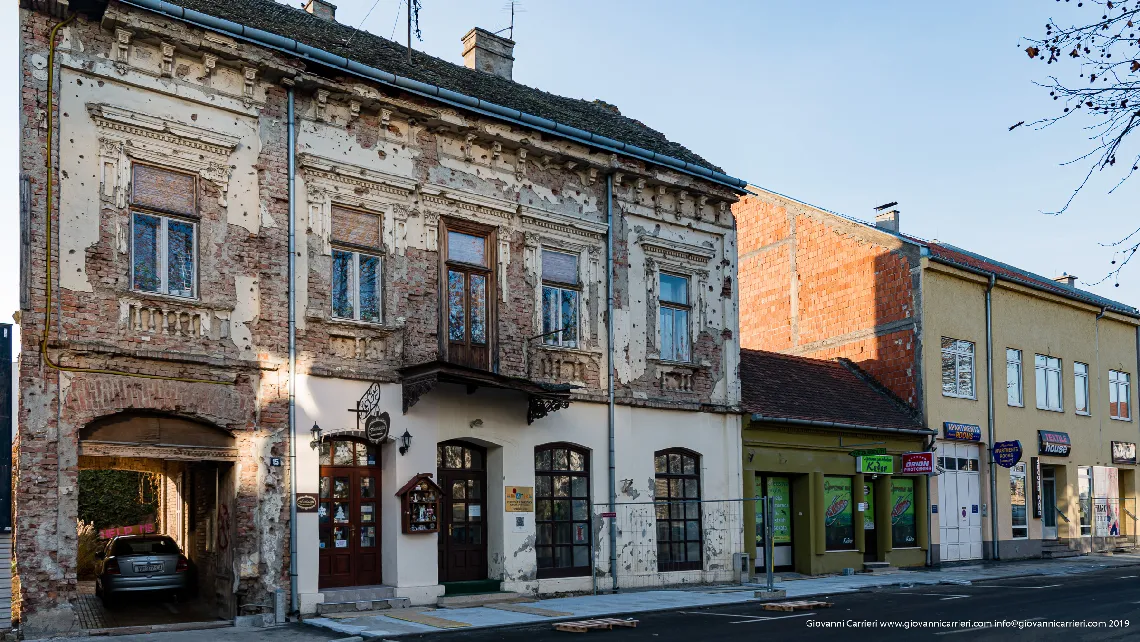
[140,0,722,172]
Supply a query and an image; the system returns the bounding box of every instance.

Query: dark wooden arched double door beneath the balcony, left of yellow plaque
[435,441,487,582]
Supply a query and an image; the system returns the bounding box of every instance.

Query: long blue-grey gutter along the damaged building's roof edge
[119,0,748,193]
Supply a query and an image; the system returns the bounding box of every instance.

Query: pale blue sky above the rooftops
[0,0,1140,355]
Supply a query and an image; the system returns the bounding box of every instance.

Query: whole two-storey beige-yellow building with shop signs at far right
[921,244,1140,561]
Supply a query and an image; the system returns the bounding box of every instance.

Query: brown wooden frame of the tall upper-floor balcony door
[439,217,498,371]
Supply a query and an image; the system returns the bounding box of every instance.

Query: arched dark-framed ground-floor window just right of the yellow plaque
[535,444,593,579]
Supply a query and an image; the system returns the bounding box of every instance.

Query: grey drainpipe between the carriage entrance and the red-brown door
[286,82,299,613]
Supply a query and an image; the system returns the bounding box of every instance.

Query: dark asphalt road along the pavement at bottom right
[400,567,1140,642]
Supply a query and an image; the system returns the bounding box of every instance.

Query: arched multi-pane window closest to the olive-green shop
[653,448,701,572]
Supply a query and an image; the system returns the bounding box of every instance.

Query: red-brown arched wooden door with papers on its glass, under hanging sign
[317,437,381,588]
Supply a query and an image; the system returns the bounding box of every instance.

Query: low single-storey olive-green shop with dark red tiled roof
[740,350,934,575]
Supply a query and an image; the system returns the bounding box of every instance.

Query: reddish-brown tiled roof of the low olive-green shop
[740,350,934,434]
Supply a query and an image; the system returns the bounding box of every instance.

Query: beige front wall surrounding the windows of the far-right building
[921,259,1138,561]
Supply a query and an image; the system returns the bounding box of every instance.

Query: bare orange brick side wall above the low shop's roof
[733,193,921,407]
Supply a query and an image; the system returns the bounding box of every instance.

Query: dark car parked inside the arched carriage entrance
[95,535,194,606]
